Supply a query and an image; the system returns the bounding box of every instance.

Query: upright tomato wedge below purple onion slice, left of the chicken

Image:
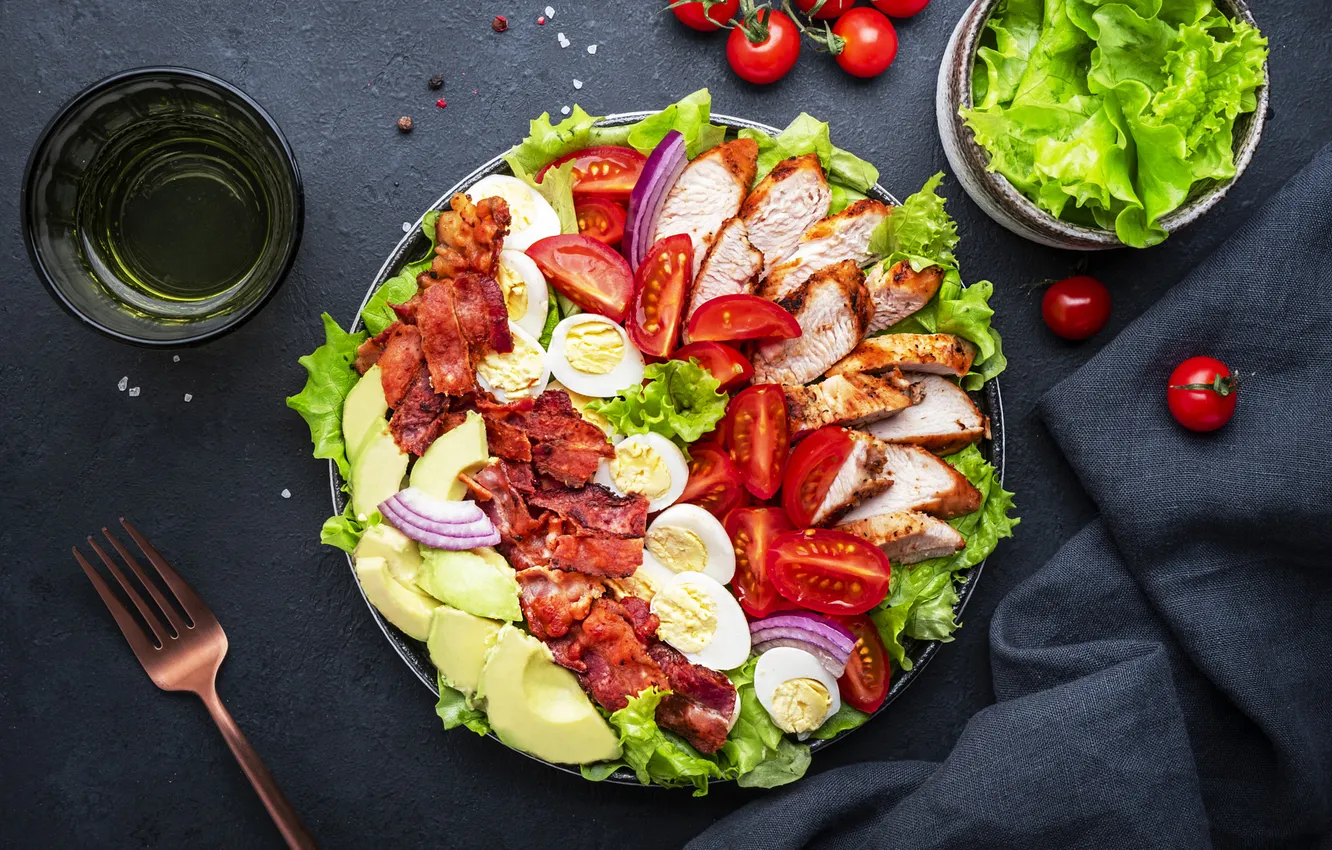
[625,233,694,357]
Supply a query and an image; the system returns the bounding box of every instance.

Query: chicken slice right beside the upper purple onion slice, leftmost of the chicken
[653,139,758,277]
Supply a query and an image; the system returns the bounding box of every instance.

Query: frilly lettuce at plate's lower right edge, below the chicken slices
[870,445,1018,670]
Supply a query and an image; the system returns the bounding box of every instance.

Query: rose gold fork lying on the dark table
[73,517,318,849]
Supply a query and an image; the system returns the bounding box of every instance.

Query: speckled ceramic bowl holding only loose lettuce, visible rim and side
[935,0,1268,250]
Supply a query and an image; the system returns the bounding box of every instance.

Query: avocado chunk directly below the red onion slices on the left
[417,546,522,622]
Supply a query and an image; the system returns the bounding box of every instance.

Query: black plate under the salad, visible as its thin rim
[329,112,1004,785]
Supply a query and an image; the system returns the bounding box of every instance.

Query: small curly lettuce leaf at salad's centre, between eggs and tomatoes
[587,357,727,449]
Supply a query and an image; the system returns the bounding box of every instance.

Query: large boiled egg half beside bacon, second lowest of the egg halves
[651,573,750,670]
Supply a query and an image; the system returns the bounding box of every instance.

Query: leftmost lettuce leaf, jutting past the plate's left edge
[286,313,365,478]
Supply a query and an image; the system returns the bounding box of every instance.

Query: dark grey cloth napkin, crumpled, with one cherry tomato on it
[690,148,1332,850]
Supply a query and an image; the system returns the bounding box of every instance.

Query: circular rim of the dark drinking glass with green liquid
[19,65,305,349]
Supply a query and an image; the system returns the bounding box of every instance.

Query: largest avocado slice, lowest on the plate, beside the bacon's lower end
[477,625,619,765]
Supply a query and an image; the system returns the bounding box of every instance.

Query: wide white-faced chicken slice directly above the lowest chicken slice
[842,442,980,524]
